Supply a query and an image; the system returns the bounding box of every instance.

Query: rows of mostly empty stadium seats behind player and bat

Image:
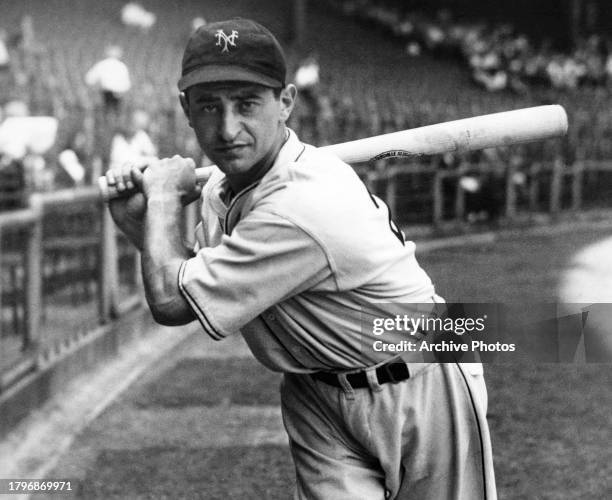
[0,0,612,168]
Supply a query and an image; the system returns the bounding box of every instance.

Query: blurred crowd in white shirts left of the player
[0,2,177,205]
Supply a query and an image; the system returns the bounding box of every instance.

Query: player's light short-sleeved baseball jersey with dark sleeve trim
[179,131,436,373]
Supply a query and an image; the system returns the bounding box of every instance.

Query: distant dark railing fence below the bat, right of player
[358,160,612,227]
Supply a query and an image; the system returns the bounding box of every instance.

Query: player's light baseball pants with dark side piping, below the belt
[281,363,497,500]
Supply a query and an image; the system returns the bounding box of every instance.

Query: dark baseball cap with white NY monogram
[178,18,287,92]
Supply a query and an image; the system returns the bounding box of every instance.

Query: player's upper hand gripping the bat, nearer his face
[139,155,202,205]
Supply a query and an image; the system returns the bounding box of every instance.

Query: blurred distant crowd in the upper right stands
[332,0,612,92]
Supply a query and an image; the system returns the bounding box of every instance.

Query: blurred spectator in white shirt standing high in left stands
[85,45,132,118]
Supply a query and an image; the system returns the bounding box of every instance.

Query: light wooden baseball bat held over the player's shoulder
[99,104,568,200]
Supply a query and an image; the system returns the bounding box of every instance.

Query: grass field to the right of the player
[419,227,612,500]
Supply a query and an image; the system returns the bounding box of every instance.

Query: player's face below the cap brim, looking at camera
[186,82,295,185]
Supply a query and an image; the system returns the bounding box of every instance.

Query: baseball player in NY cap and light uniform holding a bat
[107,19,496,500]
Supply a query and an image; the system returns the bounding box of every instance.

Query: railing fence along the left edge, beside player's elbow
[0,187,140,392]
